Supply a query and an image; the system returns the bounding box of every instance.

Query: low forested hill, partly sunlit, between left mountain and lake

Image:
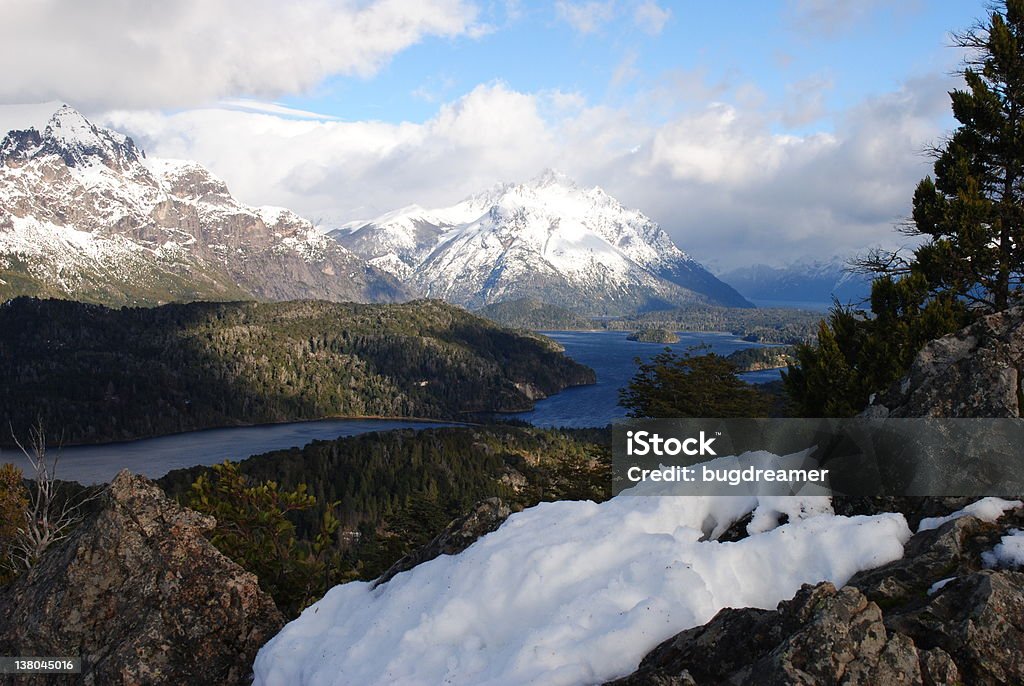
[0,298,594,444]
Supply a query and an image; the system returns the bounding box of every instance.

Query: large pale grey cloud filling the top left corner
[0,0,482,108]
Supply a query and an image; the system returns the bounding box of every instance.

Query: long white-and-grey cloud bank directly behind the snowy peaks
[94,77,952,268]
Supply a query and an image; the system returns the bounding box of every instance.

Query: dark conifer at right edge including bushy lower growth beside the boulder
[785,0,1024,416]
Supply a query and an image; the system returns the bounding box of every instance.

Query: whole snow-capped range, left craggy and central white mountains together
[0,105,751,315]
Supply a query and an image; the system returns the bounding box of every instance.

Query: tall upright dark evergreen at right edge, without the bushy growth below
[866,0,1024,312]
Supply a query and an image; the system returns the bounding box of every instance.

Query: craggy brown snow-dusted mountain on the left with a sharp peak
[0,105,404,304]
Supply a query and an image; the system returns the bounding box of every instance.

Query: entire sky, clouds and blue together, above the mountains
[0,0,986,269]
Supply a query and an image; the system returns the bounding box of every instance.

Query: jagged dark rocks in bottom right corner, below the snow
[611,509,1024,686]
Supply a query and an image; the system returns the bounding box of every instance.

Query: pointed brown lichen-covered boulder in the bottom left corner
[0,471,284,685]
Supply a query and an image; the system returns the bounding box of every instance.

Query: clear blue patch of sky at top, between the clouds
[279,0,985,131]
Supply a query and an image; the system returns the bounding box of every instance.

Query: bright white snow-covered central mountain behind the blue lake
[331,170,750,314]
